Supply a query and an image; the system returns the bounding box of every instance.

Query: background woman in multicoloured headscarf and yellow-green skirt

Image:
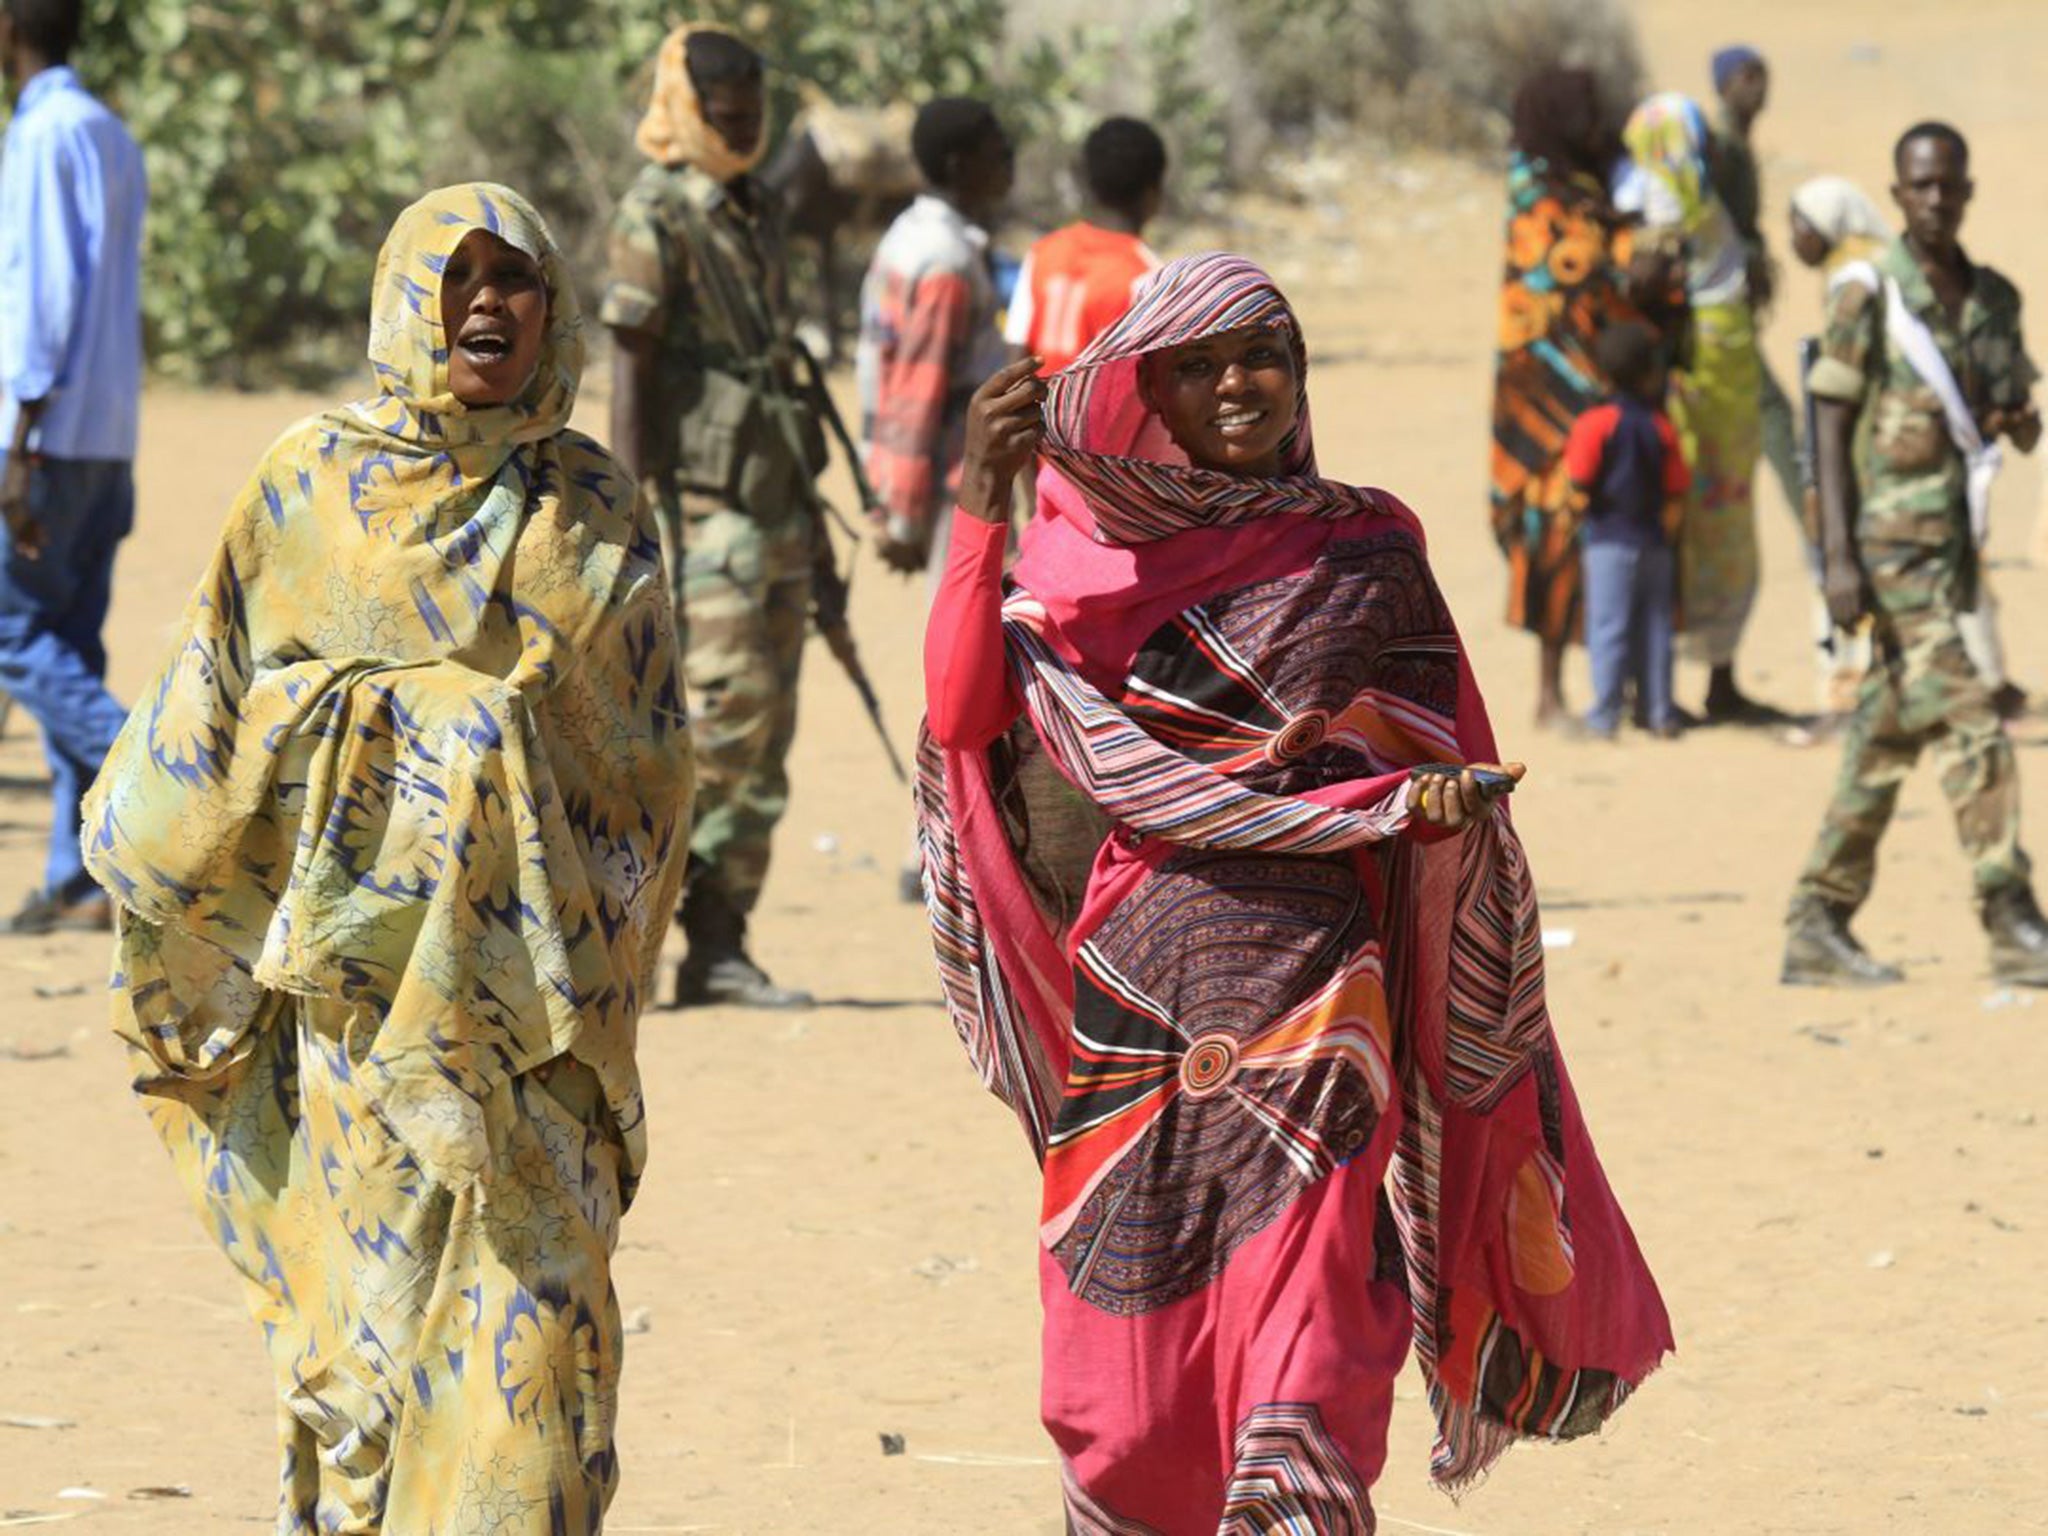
[1622,92,1782,725]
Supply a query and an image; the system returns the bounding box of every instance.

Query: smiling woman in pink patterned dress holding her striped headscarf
[920,254,1671,1536]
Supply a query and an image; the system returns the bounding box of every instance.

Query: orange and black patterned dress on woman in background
[1493,154,1632,645]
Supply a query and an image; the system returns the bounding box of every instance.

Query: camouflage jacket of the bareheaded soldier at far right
[1806,240,2040,561]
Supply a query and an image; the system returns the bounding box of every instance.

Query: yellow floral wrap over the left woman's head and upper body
[84,184,690,1184]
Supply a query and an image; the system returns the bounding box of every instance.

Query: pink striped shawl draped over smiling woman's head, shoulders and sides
[918,254,1671,1487]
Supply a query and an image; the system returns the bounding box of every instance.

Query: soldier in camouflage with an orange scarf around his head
[600,27,823,1008]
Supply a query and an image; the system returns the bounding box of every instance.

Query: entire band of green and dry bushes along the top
[36,0,1638,383]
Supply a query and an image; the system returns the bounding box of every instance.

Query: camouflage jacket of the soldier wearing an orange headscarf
[598,164,809,512]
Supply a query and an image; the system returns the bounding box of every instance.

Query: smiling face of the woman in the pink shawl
[1139,330,1300,475]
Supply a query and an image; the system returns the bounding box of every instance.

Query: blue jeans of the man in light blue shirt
[0,455,135,901]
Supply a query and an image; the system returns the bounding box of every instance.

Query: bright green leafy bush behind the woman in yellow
[59,0,1040,383]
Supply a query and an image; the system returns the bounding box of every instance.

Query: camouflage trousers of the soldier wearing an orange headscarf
[657,492,813,915]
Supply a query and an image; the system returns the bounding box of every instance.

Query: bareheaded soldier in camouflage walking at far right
[1784,123,2048,985]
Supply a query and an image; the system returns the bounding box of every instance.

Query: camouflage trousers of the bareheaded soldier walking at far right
[1794,545,2028,911]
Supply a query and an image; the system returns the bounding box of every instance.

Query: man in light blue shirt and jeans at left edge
[0,0,147,934]
